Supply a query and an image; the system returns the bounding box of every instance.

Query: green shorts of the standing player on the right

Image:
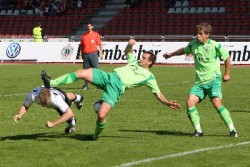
[189,77,222,102]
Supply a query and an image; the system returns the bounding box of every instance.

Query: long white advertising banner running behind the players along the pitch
[0,42,250,64]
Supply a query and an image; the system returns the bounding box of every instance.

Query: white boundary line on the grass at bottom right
[116,141,250,167]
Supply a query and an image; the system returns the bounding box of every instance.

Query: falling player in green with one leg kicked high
[41,39,181,140]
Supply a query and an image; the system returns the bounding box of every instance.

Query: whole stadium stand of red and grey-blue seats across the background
[0,0,250,41]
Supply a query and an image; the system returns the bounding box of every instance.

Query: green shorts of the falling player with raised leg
[92,68,123,107]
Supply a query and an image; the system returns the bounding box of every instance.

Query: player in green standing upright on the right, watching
[163,23,238,137]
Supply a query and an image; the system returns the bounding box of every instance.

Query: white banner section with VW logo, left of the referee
[0,42,79,62]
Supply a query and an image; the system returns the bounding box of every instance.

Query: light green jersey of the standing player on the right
[184,39,229,84]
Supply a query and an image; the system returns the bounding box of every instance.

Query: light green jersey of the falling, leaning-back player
[114,54,160,93]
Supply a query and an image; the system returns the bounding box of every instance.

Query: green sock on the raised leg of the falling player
[50,72,78,87]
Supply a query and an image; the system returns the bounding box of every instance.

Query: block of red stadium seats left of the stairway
[0,0,101,36]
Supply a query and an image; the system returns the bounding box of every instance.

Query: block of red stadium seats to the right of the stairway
[99,0,250,35]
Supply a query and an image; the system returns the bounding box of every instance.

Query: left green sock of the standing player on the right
[187,106,202,132]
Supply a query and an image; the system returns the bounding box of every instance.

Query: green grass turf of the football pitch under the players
[0,64,250,167]
